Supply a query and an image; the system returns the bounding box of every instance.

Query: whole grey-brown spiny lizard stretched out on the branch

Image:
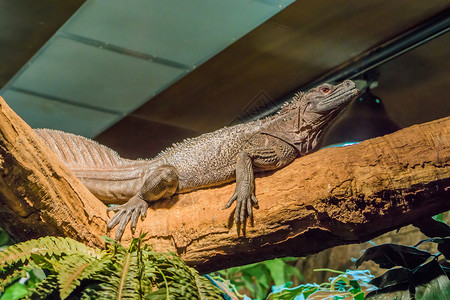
[35,80,358,240]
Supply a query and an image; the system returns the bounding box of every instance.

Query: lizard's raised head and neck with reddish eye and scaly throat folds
[264,80,358,155]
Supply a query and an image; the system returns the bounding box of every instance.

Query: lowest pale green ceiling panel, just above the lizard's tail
[2,89,120,136]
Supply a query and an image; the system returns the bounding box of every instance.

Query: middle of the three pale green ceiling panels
[11,36,186,114]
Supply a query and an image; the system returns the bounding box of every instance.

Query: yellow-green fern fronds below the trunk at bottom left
[0,235,223,299]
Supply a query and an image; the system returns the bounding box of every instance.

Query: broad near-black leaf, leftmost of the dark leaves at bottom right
[355,244,431,269]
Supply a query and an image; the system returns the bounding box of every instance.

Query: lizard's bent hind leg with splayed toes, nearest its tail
[107,165,178,240]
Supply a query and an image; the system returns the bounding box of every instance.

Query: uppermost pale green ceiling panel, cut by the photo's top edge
[63,0,293,66]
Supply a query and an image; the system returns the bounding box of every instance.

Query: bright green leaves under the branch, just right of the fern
[210,257,303,299]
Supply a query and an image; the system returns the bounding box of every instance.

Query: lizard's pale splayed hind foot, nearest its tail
[107,195,148,240]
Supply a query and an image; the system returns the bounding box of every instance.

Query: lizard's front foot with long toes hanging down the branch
[223,191,258,235]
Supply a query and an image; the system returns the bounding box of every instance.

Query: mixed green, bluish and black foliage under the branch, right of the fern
[210,215,450,300]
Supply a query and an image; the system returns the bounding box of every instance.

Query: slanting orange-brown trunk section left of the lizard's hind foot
[0,97,107,246]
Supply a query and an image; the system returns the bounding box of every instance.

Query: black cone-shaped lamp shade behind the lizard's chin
[322,87,400,148]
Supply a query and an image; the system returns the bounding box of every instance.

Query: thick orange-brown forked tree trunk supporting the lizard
[0,95,450,272]
